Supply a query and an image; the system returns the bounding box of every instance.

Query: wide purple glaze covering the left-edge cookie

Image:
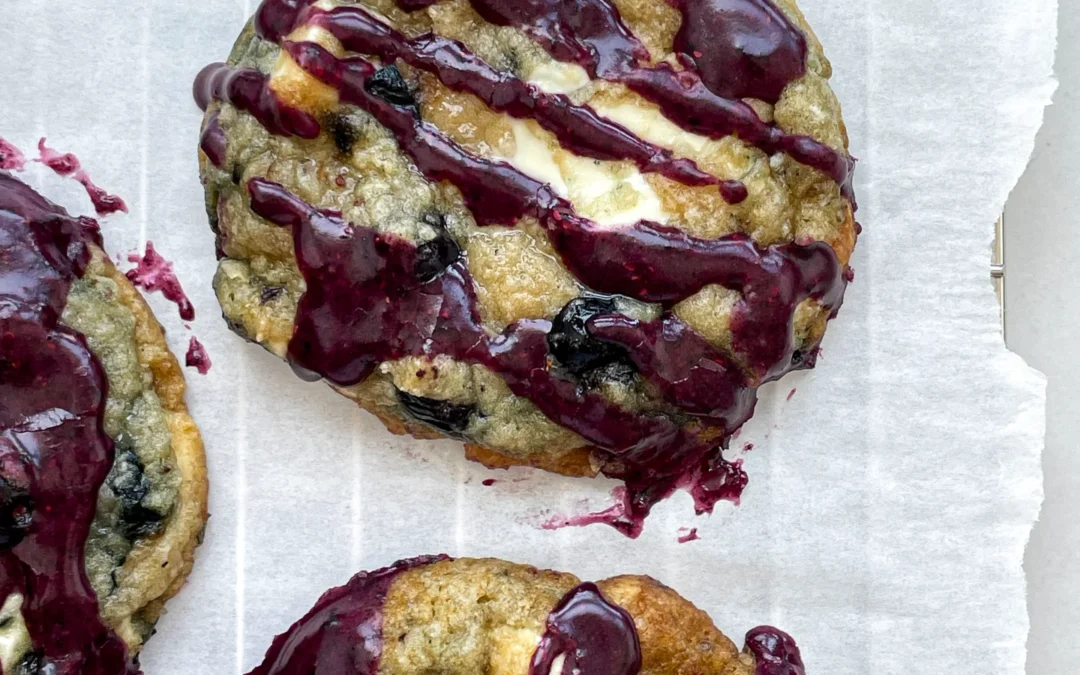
[0,173,138,675]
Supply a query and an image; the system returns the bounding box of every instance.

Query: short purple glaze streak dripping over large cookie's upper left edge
[193,64,321,143]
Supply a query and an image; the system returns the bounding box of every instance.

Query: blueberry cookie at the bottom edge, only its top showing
[249,556,806,675]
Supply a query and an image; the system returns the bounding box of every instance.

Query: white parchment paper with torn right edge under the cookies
[0,0,1056,675]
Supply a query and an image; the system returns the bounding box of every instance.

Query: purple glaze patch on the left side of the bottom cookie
[248,555,449,675]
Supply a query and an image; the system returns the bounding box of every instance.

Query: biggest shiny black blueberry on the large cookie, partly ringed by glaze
[548,297,634,376]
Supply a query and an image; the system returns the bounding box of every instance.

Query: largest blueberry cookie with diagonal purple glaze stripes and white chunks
[194,0,856,531]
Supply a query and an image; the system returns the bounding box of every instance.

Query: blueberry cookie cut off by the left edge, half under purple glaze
[0,172,206,675]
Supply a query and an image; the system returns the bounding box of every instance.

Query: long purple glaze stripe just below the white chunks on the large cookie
[285,42,843,308]
